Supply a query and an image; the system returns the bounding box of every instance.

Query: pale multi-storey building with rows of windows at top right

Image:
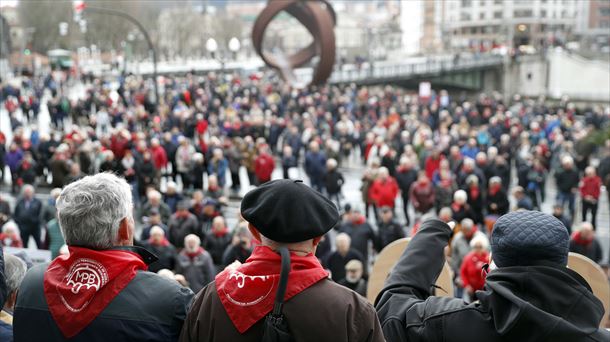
[443,0,576,51]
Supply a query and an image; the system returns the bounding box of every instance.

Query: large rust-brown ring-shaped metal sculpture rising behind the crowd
[252,0,336,85]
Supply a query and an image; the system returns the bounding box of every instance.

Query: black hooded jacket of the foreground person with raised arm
[375,220,610,342]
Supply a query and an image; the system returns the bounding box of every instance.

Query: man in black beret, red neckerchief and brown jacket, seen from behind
[180,179,384,342]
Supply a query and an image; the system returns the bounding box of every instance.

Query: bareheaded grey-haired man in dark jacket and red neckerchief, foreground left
[13,173,193,342]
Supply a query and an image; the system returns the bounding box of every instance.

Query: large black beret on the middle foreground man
[241,179,339,243]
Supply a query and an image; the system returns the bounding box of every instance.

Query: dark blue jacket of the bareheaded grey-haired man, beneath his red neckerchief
[13,249,193,342]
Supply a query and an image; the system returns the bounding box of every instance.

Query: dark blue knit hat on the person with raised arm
[491,210,570,267]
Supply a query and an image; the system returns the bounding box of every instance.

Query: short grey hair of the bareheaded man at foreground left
[56,173,133,249]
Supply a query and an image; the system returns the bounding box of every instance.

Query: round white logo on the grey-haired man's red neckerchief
[65,259,108,294]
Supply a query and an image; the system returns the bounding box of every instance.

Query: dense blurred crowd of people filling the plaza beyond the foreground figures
[0,69,610,299]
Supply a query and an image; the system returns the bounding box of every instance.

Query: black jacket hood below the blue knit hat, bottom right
[476,266,610,341]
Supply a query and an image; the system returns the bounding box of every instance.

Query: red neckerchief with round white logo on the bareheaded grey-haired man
[43,247,148,338]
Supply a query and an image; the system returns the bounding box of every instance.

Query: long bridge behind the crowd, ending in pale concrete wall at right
[108,49,610,101]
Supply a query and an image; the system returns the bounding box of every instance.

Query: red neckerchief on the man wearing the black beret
[216,246,328,334]
